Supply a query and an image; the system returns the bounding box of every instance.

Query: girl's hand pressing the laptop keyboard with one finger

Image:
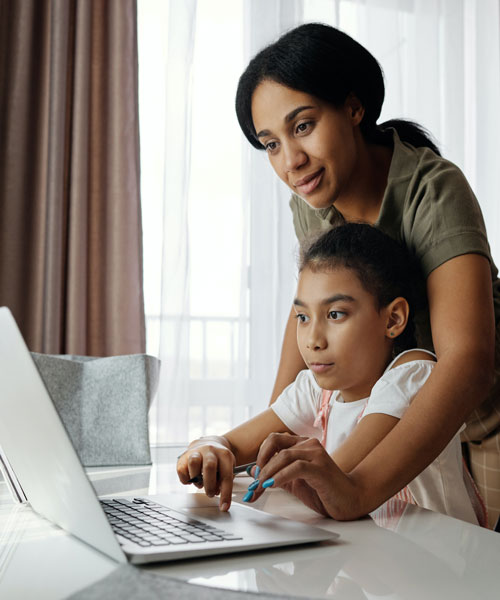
[177,436,236,511]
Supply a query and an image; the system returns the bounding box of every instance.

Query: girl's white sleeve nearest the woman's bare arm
[363,360,436,419]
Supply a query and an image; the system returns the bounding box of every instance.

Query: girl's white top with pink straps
[271,350,485,525]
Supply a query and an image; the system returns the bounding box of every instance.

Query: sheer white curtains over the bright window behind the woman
[138,0,500,443]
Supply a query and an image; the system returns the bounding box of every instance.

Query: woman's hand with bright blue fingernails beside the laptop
[251,433,359,520]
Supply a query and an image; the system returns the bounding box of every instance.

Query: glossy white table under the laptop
[0,442,500,600]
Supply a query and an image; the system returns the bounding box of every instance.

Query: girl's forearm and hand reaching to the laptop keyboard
[177,408,290,510]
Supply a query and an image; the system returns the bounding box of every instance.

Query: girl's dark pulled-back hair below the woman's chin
[299,223,418,354]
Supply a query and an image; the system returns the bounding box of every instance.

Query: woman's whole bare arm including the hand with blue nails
[249,254,495,520]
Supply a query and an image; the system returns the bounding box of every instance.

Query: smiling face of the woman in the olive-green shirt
[252,80,363,208]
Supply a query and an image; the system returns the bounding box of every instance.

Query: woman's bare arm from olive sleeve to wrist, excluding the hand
[350,254,495,512]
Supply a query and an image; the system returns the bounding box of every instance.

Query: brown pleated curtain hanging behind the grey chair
[0,0,145,356]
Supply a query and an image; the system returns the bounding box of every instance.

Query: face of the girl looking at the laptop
[294,267,393,402]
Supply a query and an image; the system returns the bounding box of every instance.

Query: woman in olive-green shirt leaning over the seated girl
[236,24,500,525]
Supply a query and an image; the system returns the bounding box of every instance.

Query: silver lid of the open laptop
[0,308,126,562]
